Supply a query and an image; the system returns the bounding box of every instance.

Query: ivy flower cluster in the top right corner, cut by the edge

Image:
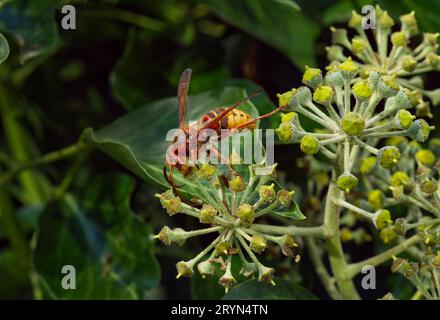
[326,6,440,106]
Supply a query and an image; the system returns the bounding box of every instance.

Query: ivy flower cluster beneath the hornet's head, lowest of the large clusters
[155,164,304,291]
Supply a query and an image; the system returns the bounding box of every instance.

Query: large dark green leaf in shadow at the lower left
[34,174,160,299]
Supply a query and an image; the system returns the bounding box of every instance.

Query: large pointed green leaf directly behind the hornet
[83,87,258,199]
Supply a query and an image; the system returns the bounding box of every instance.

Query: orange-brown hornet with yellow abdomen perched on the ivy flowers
[163,69,282,201]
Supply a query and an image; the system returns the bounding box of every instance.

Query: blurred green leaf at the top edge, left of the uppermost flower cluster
[200,0,319,69]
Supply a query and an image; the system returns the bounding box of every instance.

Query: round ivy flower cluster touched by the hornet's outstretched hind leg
[276,57,434,193]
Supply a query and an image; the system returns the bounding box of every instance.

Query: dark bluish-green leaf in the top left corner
[0,0,62,62]
